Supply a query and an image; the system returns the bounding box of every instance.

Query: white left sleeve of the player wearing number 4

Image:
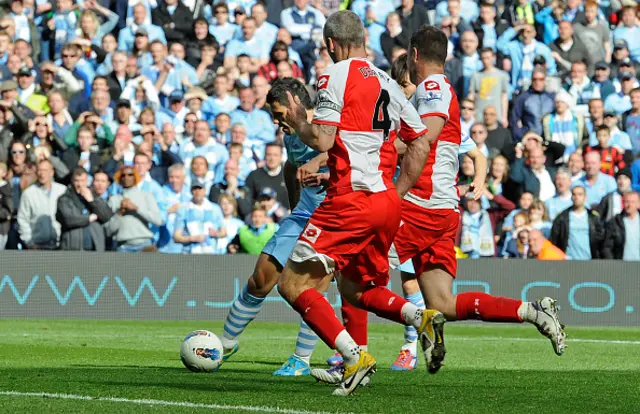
[313,65,348,126]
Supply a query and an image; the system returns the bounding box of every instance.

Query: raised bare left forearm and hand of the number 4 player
[285,92,338,152]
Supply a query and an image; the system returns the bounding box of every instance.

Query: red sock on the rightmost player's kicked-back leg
[456,292,522,322]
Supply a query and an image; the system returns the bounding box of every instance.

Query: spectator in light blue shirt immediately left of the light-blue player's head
[231,88,276,157]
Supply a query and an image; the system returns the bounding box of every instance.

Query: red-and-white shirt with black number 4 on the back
[313,58,427,197]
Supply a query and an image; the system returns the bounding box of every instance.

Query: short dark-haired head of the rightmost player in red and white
[407,24,449,85]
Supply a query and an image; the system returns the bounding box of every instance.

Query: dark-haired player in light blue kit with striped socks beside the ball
[221,79,329,376]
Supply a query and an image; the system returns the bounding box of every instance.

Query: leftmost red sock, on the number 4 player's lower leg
[293,289,344,349]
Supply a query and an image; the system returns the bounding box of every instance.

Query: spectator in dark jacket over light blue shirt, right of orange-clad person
[550,184,611,260]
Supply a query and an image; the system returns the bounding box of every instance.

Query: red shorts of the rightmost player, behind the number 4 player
[393,200,460,277]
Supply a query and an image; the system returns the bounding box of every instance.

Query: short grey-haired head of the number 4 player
[323,10,364,62]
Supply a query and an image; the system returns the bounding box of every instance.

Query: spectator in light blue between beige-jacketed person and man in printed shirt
[157,164,191,254]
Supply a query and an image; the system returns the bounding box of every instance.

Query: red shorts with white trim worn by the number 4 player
[291,189,401,286]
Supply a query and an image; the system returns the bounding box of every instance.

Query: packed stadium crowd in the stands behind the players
[0,0,640,260]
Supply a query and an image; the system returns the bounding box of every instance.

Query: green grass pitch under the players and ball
[0,320,640,414]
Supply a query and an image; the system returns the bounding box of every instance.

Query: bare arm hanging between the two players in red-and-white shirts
[396,116,445,198]
